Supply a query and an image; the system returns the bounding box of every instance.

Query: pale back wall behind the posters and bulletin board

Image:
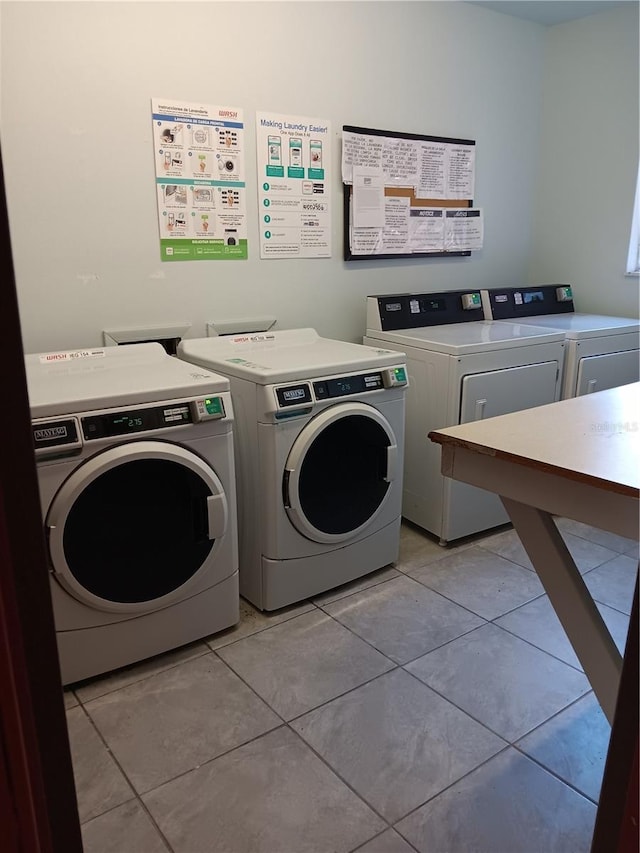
[1,2,545,351]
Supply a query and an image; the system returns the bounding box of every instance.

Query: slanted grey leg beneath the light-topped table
[501,497,622,722]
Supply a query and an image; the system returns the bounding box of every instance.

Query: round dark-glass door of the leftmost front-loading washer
[45,441,228,613]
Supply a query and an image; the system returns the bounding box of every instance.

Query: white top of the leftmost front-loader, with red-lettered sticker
[25,343,229,418]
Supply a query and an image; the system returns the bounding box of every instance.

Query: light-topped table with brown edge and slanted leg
[429,383,640,722]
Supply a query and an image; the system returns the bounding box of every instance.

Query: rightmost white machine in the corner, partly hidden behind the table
[482,284,640,400]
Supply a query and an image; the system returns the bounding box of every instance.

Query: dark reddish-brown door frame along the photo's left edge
[0,148,82,853]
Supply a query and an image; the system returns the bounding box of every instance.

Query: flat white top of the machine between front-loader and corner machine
[367,320,565,356]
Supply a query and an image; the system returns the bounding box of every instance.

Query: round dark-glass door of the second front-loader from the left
[283,403,398,542]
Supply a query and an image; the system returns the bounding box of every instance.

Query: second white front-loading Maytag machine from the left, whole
[178,329,406,610]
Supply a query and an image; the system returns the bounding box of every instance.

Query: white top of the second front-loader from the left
[178,329,402,385]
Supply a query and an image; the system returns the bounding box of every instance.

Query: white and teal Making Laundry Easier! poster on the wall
[256,112,331,258]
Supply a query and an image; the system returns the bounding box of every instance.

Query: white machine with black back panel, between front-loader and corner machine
[364,291,564,545]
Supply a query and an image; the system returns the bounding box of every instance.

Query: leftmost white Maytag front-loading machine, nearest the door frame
[25,343,239,684]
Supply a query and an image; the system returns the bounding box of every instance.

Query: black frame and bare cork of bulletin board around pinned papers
[342,124,476,261]
